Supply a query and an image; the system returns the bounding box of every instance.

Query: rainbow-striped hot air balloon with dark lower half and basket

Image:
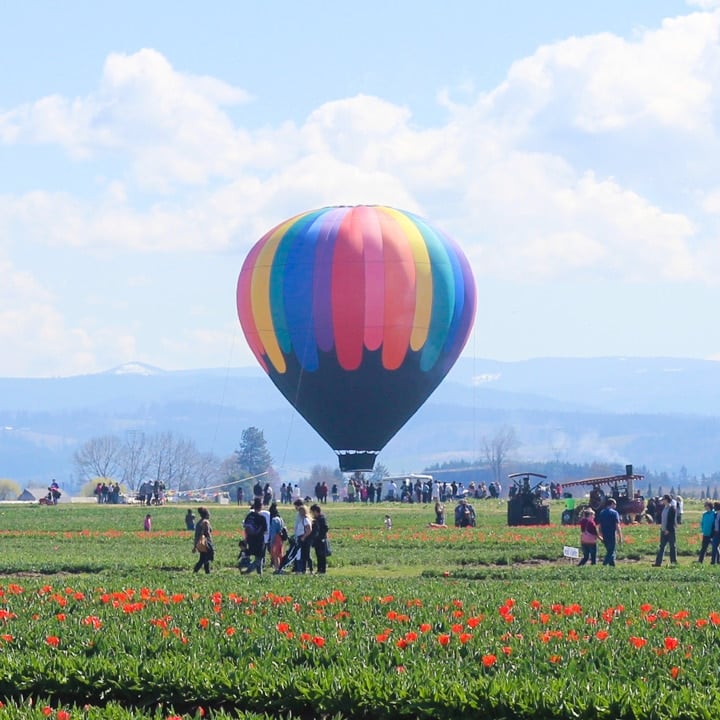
[237,205,476,472]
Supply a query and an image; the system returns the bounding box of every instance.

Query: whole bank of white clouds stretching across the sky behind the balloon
[0,5,720,374]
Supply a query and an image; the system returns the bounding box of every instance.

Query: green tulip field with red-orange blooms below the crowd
[0,501,720,720]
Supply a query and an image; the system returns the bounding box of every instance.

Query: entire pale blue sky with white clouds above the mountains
[0,0,720,377]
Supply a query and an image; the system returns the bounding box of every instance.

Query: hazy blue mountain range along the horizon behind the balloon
[0,358,720,484]
